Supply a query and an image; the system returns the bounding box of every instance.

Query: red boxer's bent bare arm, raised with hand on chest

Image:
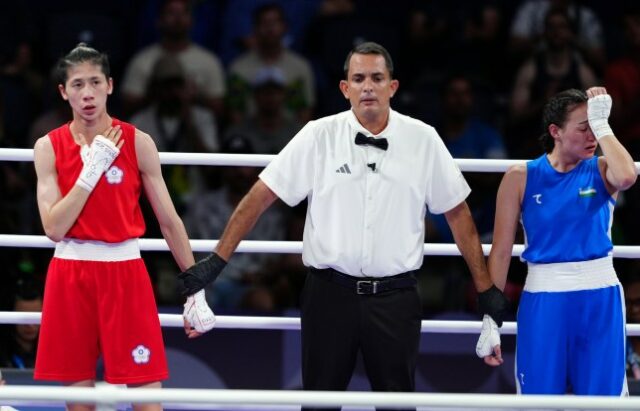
[33,136,90,241]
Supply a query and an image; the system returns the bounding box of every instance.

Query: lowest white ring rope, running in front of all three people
[0,385,640,410]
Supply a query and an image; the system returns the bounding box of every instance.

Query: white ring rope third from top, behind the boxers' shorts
[0,311,640,336]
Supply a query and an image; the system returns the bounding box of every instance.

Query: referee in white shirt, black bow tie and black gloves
[180,42,506,408]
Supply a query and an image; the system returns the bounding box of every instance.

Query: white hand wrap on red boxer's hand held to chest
[76,135,120,192]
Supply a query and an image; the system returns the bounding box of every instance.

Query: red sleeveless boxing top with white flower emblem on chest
[48,119,145,243]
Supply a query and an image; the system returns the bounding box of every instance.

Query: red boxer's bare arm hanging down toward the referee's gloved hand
[136,130,195,270]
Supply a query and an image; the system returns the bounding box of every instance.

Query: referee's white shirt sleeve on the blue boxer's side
[425,130,471,214]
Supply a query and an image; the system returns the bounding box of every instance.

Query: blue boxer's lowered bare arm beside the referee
[488,165,527,290]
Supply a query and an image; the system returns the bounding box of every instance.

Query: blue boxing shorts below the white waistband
[516,284,627,396]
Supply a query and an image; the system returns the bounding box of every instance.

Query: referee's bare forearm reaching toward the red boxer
[215,180,278,261]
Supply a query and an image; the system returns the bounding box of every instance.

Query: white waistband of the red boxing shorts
[53,238,140,261]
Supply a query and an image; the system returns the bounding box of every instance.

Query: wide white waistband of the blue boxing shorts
[524,256,620,292]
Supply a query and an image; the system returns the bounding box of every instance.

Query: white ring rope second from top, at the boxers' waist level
[0,234,640,258]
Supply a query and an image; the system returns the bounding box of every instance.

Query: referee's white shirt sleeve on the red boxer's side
[260,122,317,207]
